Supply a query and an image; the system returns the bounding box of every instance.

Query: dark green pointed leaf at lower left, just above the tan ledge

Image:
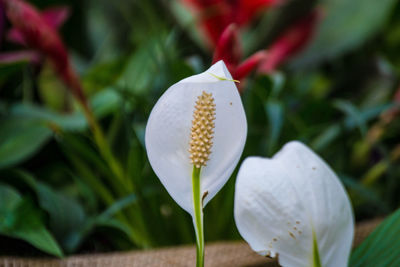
[0,184,63,257]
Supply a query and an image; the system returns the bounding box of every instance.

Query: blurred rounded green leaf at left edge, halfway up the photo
[0,117,52,169]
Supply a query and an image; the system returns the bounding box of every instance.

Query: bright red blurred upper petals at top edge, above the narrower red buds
[182,0,281,46]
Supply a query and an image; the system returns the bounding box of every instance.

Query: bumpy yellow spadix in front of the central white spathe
[189,91,215,168]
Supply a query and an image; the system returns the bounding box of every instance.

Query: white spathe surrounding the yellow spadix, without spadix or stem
[145,61,247,216]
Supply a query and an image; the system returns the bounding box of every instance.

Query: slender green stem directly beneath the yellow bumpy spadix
[192,166,204,267]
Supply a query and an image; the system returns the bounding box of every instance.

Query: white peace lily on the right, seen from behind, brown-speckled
[234,141,354,267]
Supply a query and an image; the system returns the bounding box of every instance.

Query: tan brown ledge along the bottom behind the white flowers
[0,219,381,267]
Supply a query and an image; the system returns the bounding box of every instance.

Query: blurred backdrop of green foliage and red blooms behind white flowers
[0,0,400,256]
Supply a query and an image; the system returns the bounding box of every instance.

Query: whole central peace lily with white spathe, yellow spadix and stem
[145,61,247,266]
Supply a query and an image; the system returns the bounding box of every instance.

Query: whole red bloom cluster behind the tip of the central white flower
[182,0,320,89]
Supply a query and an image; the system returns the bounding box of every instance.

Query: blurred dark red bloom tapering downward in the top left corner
[0,0,86,105]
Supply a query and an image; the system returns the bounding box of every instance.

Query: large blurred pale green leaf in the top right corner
[293,0,396,68]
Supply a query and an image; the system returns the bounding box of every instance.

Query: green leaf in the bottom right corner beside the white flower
[349,209,400,267]
